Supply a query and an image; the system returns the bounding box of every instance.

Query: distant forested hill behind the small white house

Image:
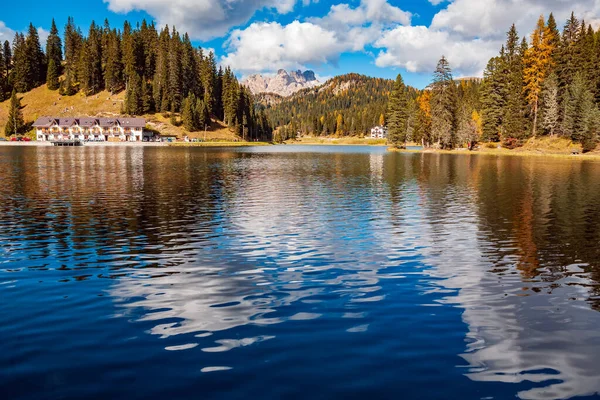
[266,74,393,140]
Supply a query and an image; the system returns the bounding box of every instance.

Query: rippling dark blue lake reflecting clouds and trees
[0,146,600,399]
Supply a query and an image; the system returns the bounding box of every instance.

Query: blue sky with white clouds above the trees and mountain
[0,0,600,88]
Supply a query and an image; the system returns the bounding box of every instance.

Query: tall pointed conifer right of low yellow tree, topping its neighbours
[431,56,456,149]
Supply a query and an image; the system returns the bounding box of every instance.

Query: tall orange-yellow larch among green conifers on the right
[523,16,554,137]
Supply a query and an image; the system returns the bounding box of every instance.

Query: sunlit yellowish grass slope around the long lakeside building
[0,85,237,141]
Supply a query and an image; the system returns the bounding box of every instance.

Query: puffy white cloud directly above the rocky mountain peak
[222,0,411,73]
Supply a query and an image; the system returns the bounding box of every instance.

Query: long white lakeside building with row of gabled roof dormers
[33,117,146,142]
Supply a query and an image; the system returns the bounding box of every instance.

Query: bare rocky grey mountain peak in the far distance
[242,69,321,97]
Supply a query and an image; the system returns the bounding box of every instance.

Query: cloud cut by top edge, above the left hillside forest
[104,0,302,40]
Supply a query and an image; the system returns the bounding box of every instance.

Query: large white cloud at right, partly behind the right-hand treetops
[373,0,600,75]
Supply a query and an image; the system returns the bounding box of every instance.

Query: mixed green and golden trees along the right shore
[387,14,600,151]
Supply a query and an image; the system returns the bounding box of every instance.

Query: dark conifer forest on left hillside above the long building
[0,18,271,140]
